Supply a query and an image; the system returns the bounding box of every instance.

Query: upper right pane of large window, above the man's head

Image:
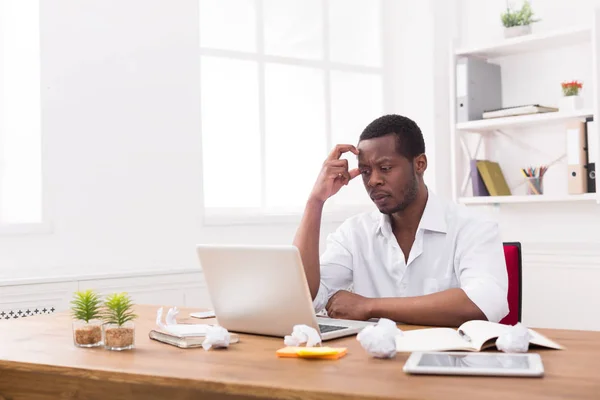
[328,0,382,67]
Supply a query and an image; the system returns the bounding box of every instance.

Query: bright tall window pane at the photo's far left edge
[0,1,42,223]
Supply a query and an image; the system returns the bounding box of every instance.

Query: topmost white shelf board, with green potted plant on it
[455,27,592,58]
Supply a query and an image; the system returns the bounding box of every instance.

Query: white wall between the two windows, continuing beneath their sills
[0,0,380,280]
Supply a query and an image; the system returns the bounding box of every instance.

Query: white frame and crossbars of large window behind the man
[198,0,392,226]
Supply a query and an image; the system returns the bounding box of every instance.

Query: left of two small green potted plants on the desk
[71,290,102,347]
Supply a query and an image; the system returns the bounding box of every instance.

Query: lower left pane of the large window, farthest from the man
[200,57,261,208]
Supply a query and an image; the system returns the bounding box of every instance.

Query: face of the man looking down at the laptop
[358,134,426,214]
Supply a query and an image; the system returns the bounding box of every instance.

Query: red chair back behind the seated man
[500,242,522,325]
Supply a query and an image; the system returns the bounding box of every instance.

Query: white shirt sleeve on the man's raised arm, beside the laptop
[313,223,352,312]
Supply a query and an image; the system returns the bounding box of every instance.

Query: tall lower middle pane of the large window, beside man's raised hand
[265,64,327,208]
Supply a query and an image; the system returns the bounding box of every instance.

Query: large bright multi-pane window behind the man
[200,0,384,222]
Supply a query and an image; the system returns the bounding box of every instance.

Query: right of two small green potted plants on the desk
[102,293,137,351]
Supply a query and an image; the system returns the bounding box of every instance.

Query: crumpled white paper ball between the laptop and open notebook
[356,318,403,358]
